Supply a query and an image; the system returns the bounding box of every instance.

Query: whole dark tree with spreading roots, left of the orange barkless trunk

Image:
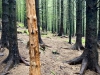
[0,0,29,75]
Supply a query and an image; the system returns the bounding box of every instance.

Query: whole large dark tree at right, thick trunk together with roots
[68,0,100,75]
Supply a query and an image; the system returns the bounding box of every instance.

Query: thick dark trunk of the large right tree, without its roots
[84,0,100,72]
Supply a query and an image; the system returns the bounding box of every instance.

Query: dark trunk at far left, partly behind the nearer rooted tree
[1,0,9,47]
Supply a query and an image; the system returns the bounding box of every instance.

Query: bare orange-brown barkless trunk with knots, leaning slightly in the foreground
[26,0,41,75]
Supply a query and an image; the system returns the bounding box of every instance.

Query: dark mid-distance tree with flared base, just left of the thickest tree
[72,0,84,50]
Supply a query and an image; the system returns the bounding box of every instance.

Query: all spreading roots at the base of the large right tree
[67,55,100,75]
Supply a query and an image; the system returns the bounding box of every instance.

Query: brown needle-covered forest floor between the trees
[0,27,100,75]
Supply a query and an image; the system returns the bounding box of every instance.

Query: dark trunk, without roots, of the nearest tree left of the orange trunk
[9,0,20,65]
